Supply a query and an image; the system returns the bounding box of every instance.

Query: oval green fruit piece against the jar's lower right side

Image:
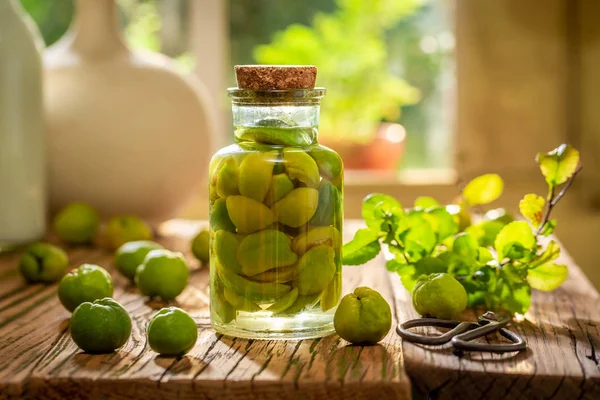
[294,244,337,295]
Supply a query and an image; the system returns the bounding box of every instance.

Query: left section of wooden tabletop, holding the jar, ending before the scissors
[0,222,410,400]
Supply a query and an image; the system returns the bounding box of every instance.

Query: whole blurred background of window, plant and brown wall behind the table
[21,0,600,284]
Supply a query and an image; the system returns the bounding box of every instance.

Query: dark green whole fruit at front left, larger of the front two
[69,298,131,354]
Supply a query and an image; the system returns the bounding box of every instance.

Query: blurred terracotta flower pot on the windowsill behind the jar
[319,122,406,171]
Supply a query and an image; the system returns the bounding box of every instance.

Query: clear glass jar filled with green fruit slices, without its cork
[209,65,343,339]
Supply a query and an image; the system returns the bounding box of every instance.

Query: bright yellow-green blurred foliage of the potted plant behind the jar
[254,0,421,142]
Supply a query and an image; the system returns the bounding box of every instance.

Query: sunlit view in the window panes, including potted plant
[22,0,455,171]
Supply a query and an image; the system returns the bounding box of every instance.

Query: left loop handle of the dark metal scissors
[396,318,478,346]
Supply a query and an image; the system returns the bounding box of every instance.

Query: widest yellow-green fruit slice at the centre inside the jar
[237,229,298,276]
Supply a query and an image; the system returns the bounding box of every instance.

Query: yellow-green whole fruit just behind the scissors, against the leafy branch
[412,273,467,319]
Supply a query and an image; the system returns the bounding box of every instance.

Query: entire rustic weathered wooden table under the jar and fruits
[0,221,600,400]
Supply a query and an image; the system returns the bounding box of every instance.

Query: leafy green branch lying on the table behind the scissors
[344,145,582,313]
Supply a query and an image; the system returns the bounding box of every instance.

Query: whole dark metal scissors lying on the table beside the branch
[396,311,527,353]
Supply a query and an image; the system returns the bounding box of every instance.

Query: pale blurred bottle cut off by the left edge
[0,0,46,252]
